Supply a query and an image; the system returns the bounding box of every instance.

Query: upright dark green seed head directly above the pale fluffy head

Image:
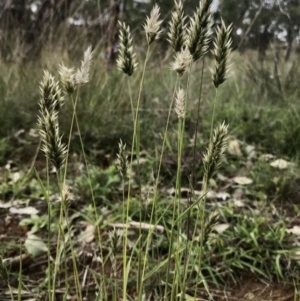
[168,0,186,52]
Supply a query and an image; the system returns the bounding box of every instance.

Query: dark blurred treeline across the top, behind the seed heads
[0,0,300,62]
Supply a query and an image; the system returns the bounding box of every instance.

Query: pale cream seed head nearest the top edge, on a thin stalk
[144,4,162,45]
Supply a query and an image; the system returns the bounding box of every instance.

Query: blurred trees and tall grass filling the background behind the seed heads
[0,0,300,164]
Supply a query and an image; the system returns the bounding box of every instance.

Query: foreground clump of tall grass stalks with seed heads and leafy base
[17,0,298,301]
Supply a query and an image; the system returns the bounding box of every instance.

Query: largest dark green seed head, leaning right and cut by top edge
[187,0,213,62]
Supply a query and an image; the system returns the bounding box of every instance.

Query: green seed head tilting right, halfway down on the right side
[203,122,228,181]
